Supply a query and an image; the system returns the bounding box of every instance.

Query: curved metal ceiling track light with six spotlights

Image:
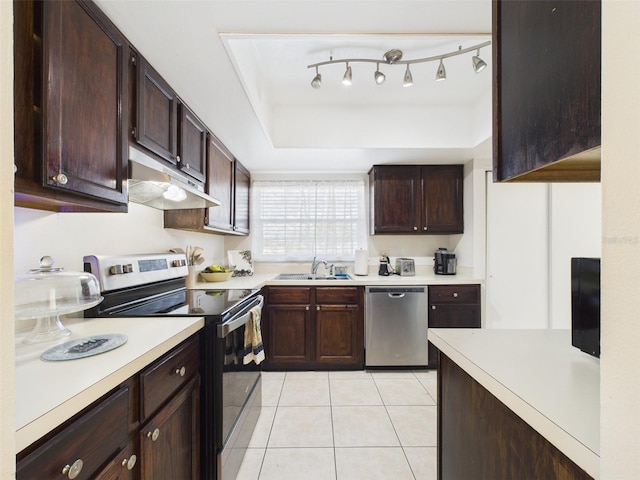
[307,41,491,88]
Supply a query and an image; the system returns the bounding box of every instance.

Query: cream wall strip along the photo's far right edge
[600,0,640,480]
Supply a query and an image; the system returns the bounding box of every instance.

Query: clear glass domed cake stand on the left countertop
[14,256,103,343]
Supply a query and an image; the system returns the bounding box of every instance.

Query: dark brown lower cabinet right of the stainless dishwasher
[428,285,481,368]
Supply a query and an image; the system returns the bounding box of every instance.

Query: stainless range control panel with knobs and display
[83,253,189,292]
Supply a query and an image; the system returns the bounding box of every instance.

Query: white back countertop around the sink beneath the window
[188,267,484,290]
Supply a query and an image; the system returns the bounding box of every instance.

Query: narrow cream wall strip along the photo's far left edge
[0,1,15,480]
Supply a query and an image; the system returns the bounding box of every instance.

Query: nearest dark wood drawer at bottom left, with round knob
[16,385,129,480]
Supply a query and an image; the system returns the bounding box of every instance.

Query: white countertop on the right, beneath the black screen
[429,329,600,479]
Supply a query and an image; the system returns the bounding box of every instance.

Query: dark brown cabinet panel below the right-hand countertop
[438,353,592,480]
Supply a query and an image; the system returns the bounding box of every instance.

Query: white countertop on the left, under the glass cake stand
[15,317,204,452]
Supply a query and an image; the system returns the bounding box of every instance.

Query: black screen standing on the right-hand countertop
[571,258,600,357]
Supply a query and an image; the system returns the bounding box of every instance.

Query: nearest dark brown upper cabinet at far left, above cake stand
[14,1,129,212]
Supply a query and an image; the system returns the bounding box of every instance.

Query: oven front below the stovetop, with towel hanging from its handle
[215,295,264,480]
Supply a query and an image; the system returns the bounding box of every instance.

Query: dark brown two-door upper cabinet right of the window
[369,165,464,235]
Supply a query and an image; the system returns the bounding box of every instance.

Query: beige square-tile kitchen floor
[237,370,437,480]
